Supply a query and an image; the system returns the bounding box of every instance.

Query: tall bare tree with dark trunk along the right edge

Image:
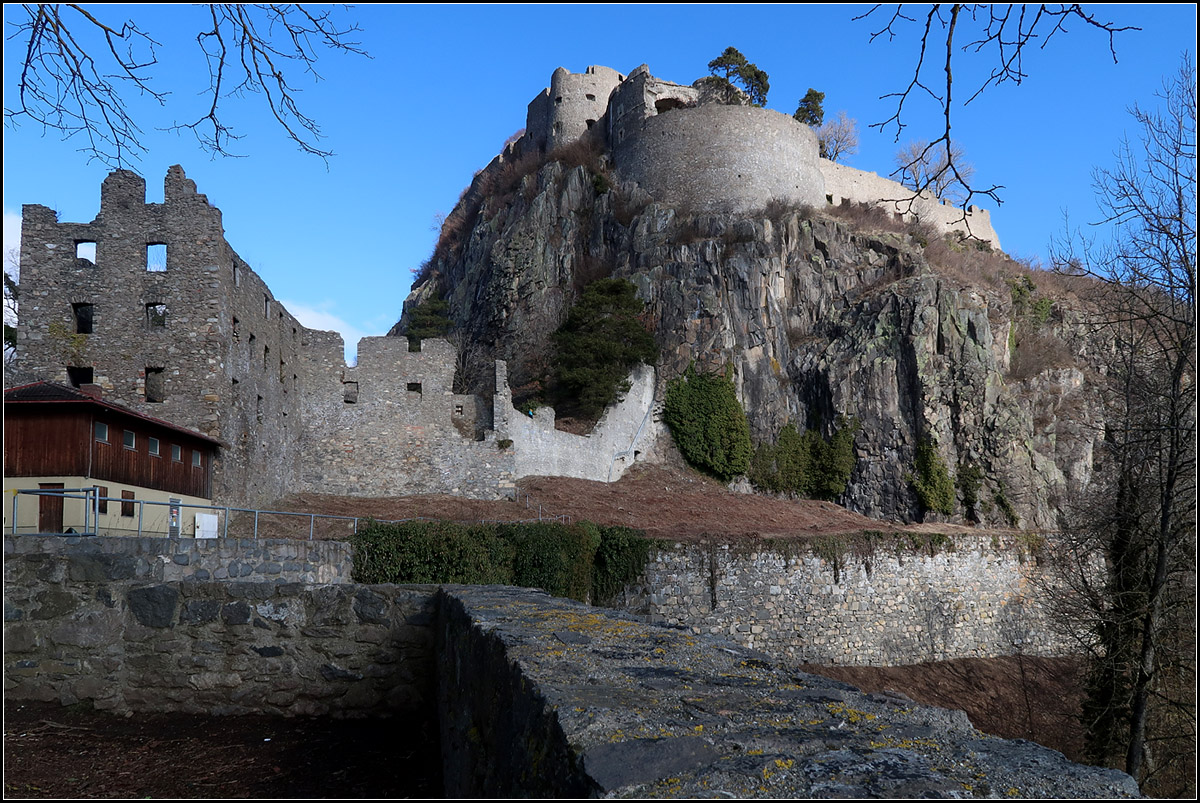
[1055,56,1196,793]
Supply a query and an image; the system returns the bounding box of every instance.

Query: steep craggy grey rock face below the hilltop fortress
[405,162,1103,528]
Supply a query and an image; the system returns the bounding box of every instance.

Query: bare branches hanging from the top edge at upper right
[854,4,1140,205]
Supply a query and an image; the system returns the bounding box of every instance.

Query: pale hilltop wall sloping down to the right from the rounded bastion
[818,158,1000,248]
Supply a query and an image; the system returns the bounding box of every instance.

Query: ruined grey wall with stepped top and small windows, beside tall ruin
[295,337,512,499]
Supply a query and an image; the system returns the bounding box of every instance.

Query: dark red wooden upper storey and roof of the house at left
[4,382,221,498]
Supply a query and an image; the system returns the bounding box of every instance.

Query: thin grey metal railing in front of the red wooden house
[10,486,574,540]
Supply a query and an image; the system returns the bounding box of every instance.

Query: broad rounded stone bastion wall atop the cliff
[612,104,826,212]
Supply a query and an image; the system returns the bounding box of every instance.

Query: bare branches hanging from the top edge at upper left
[5,4,366,167]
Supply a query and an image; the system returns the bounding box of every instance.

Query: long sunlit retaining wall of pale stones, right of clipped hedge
[623,537,1070,666]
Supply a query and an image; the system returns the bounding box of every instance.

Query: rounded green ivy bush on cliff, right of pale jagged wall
[662,366,752,483]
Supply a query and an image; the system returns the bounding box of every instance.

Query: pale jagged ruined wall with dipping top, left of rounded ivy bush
[496,361,662,483]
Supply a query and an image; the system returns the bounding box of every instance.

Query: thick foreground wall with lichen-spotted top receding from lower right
[438,586,1138,798]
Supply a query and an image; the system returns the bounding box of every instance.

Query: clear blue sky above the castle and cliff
[4,5,1196,362]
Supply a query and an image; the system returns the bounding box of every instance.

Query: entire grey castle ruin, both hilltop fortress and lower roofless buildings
[17,65,998,505]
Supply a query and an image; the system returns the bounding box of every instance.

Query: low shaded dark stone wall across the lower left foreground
[5,539,437,717]
